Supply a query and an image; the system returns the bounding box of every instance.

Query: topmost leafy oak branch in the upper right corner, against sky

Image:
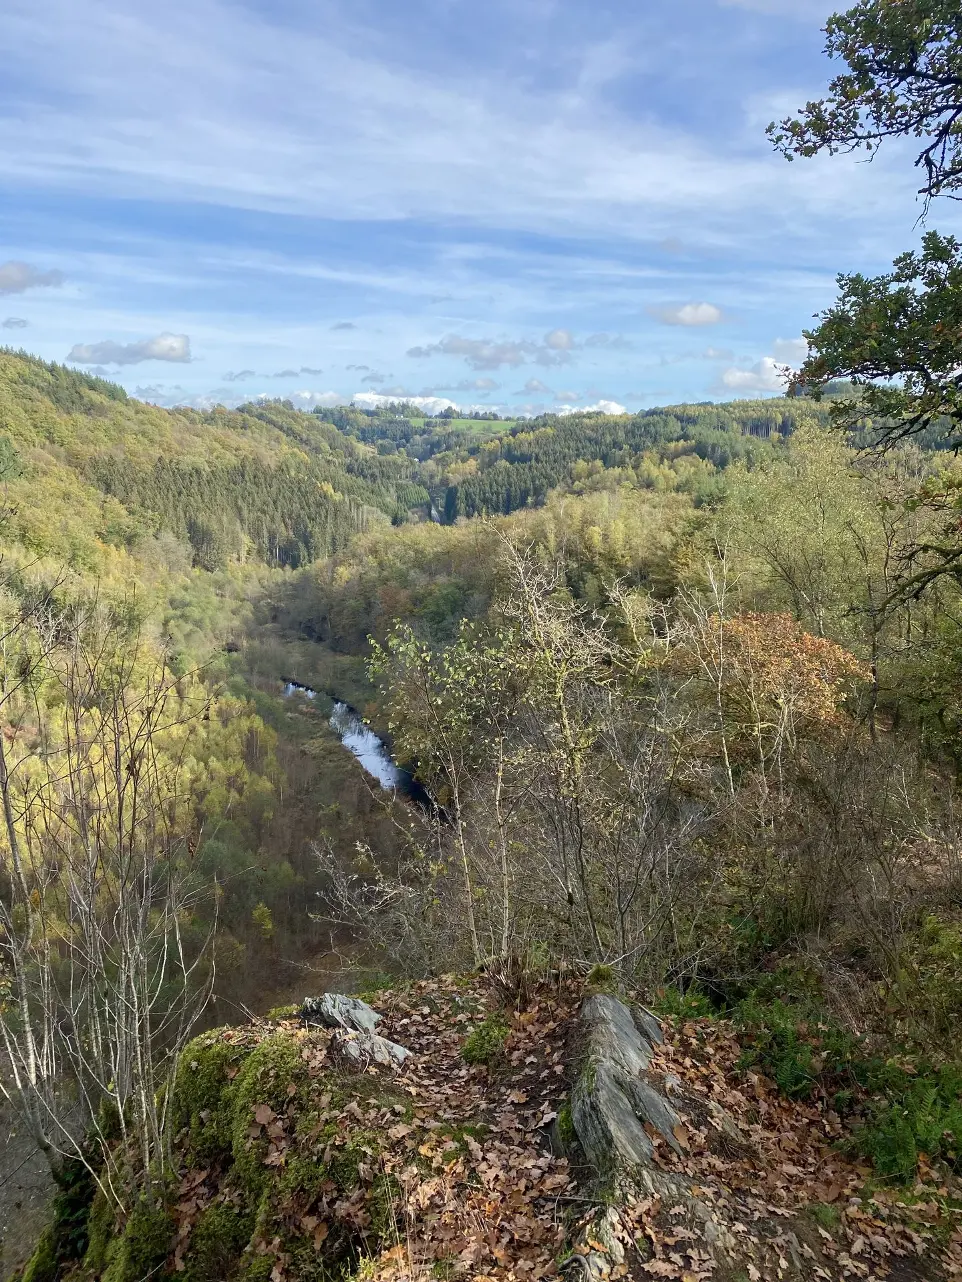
[768,0,962,201]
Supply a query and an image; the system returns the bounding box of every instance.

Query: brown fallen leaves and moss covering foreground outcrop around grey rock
[160,978,962,1282]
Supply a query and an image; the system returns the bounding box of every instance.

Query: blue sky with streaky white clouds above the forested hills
[0,0,959,413]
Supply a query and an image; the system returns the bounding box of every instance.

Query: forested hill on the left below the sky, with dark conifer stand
[0,351,427,569]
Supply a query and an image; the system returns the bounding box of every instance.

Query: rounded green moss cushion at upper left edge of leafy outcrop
[173,1031,250,1163]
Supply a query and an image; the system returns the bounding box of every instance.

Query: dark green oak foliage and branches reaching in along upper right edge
[768,0,962,595]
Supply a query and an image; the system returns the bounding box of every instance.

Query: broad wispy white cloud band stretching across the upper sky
[0,0,890,252]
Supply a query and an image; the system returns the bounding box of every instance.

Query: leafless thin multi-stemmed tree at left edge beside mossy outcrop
[0,596,213,1200]
